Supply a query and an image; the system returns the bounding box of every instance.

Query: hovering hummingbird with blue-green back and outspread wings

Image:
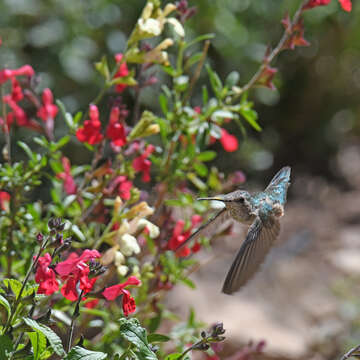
[179,166,291,294]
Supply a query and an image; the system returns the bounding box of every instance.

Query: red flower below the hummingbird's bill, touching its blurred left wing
[168,215,202,257]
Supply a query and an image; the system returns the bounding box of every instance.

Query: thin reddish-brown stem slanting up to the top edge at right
[233,0,308,99]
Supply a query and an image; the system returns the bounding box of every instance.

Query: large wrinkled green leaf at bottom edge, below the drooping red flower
[120,318,157,360]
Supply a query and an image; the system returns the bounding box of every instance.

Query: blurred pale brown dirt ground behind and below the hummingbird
[169,146,360,360]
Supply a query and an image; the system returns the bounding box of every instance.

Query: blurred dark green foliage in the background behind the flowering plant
[0,0,360,179]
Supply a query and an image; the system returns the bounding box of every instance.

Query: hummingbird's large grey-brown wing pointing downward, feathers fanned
[222,217,280,295]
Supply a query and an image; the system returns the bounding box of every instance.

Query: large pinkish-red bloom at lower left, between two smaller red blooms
[55,249,100,301]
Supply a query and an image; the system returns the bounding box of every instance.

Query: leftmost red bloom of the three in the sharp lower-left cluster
[35,253,59,295]
